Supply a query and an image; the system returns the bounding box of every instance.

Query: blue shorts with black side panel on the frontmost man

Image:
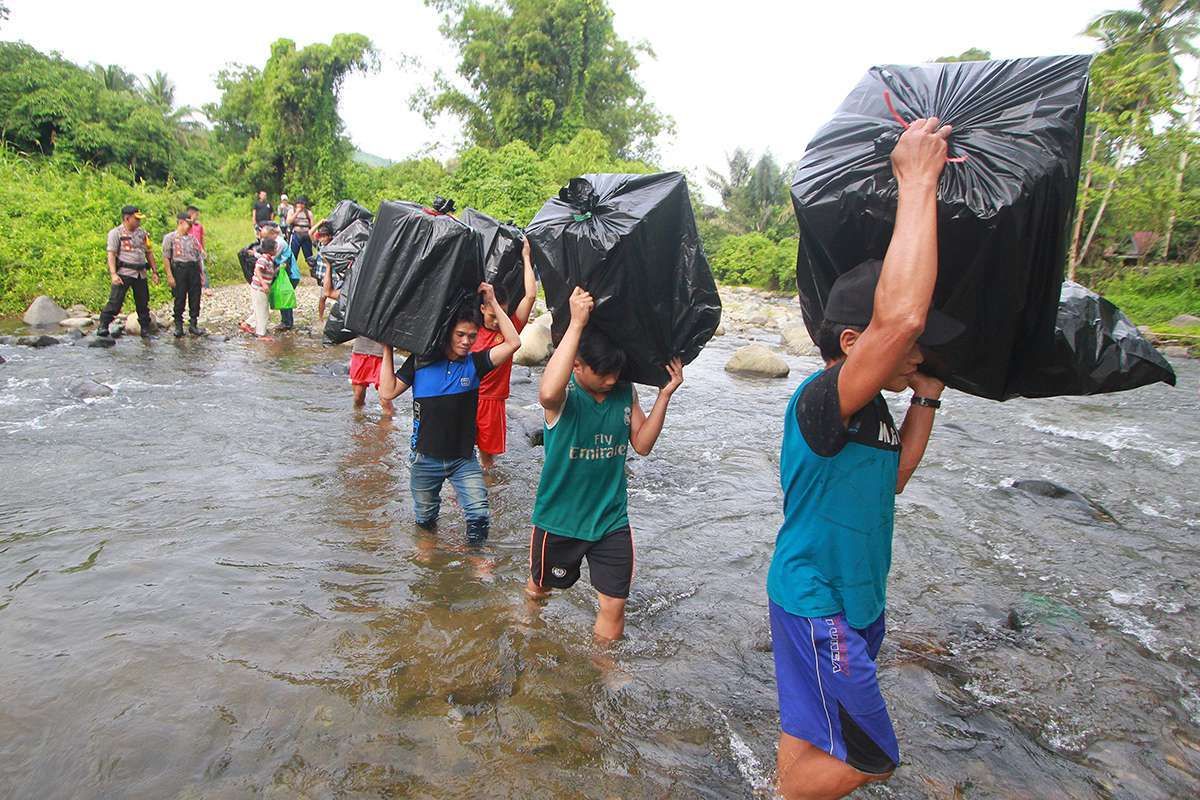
[770,602,900,775]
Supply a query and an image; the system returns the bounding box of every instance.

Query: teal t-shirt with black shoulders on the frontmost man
[767,363,900,627]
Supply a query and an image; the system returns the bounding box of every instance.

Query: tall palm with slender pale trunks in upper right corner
[1068,0,1200,279]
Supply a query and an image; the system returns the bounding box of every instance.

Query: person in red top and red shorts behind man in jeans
[470,239,538,469]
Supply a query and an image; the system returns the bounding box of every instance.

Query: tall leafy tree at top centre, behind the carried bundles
[413,0,671,158]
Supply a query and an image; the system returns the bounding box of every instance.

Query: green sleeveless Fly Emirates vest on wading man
[533,375,634,542]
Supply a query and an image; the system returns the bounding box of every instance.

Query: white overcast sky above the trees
[0,0,1118,181]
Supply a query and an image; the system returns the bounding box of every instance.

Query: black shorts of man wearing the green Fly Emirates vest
[529,525,634,600]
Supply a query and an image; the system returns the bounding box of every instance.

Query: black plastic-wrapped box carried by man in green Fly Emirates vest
[526,173,721,386]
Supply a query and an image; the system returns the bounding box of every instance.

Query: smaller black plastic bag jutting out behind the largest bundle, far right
[1018,281,1175,397]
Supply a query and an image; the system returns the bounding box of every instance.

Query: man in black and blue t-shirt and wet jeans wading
[379,283,521,545]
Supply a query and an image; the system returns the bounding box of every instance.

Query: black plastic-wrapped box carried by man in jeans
[346,201,484,355]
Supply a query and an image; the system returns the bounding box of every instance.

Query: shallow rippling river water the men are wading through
[0,326,1200,800]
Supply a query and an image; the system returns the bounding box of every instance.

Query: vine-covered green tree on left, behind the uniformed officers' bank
[204,34,378,201]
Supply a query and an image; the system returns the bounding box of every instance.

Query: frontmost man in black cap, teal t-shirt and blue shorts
[767,118,961,800]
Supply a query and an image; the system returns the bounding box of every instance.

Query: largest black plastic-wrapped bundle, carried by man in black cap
[792,55,1166,399]
